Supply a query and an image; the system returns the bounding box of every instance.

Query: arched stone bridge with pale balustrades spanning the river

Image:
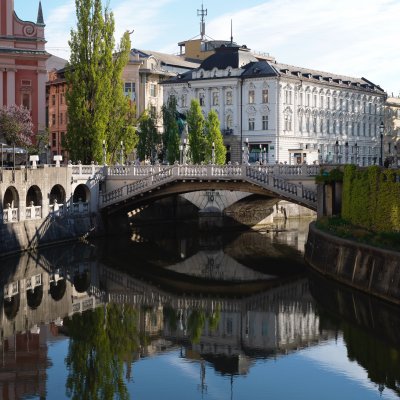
[99,164,319,214]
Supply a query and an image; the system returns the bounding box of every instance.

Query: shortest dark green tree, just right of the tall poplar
[137,111,160,162]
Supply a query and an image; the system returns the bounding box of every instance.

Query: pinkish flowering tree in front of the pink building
[0,105,33,147]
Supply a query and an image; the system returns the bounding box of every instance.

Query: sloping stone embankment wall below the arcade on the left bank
[0,213,102,257]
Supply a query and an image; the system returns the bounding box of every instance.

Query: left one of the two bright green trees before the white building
[186,99,207,164]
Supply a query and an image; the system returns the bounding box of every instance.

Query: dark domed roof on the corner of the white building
[200,45,257,71]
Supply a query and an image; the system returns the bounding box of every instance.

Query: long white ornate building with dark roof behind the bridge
[162,46,386,165]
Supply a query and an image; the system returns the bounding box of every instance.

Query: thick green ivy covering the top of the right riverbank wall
[342,165,400,232]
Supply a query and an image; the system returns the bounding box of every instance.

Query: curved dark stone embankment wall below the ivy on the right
[305,223,400,305]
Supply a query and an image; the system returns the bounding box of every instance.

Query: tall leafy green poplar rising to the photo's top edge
[66,0,137,163]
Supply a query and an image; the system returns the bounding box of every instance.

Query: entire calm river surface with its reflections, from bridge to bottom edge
[0,222,400,400]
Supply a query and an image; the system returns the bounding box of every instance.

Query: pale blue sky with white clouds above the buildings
[14,0,400,96]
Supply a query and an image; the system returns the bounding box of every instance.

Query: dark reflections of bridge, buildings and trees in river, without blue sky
[0,223,400,399]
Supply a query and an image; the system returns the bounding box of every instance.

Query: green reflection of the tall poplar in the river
[65,304,138,399]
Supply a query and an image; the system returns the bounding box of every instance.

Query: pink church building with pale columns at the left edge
[0,0,50,137]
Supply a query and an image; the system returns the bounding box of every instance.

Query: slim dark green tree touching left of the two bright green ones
[162,96,180,164]
